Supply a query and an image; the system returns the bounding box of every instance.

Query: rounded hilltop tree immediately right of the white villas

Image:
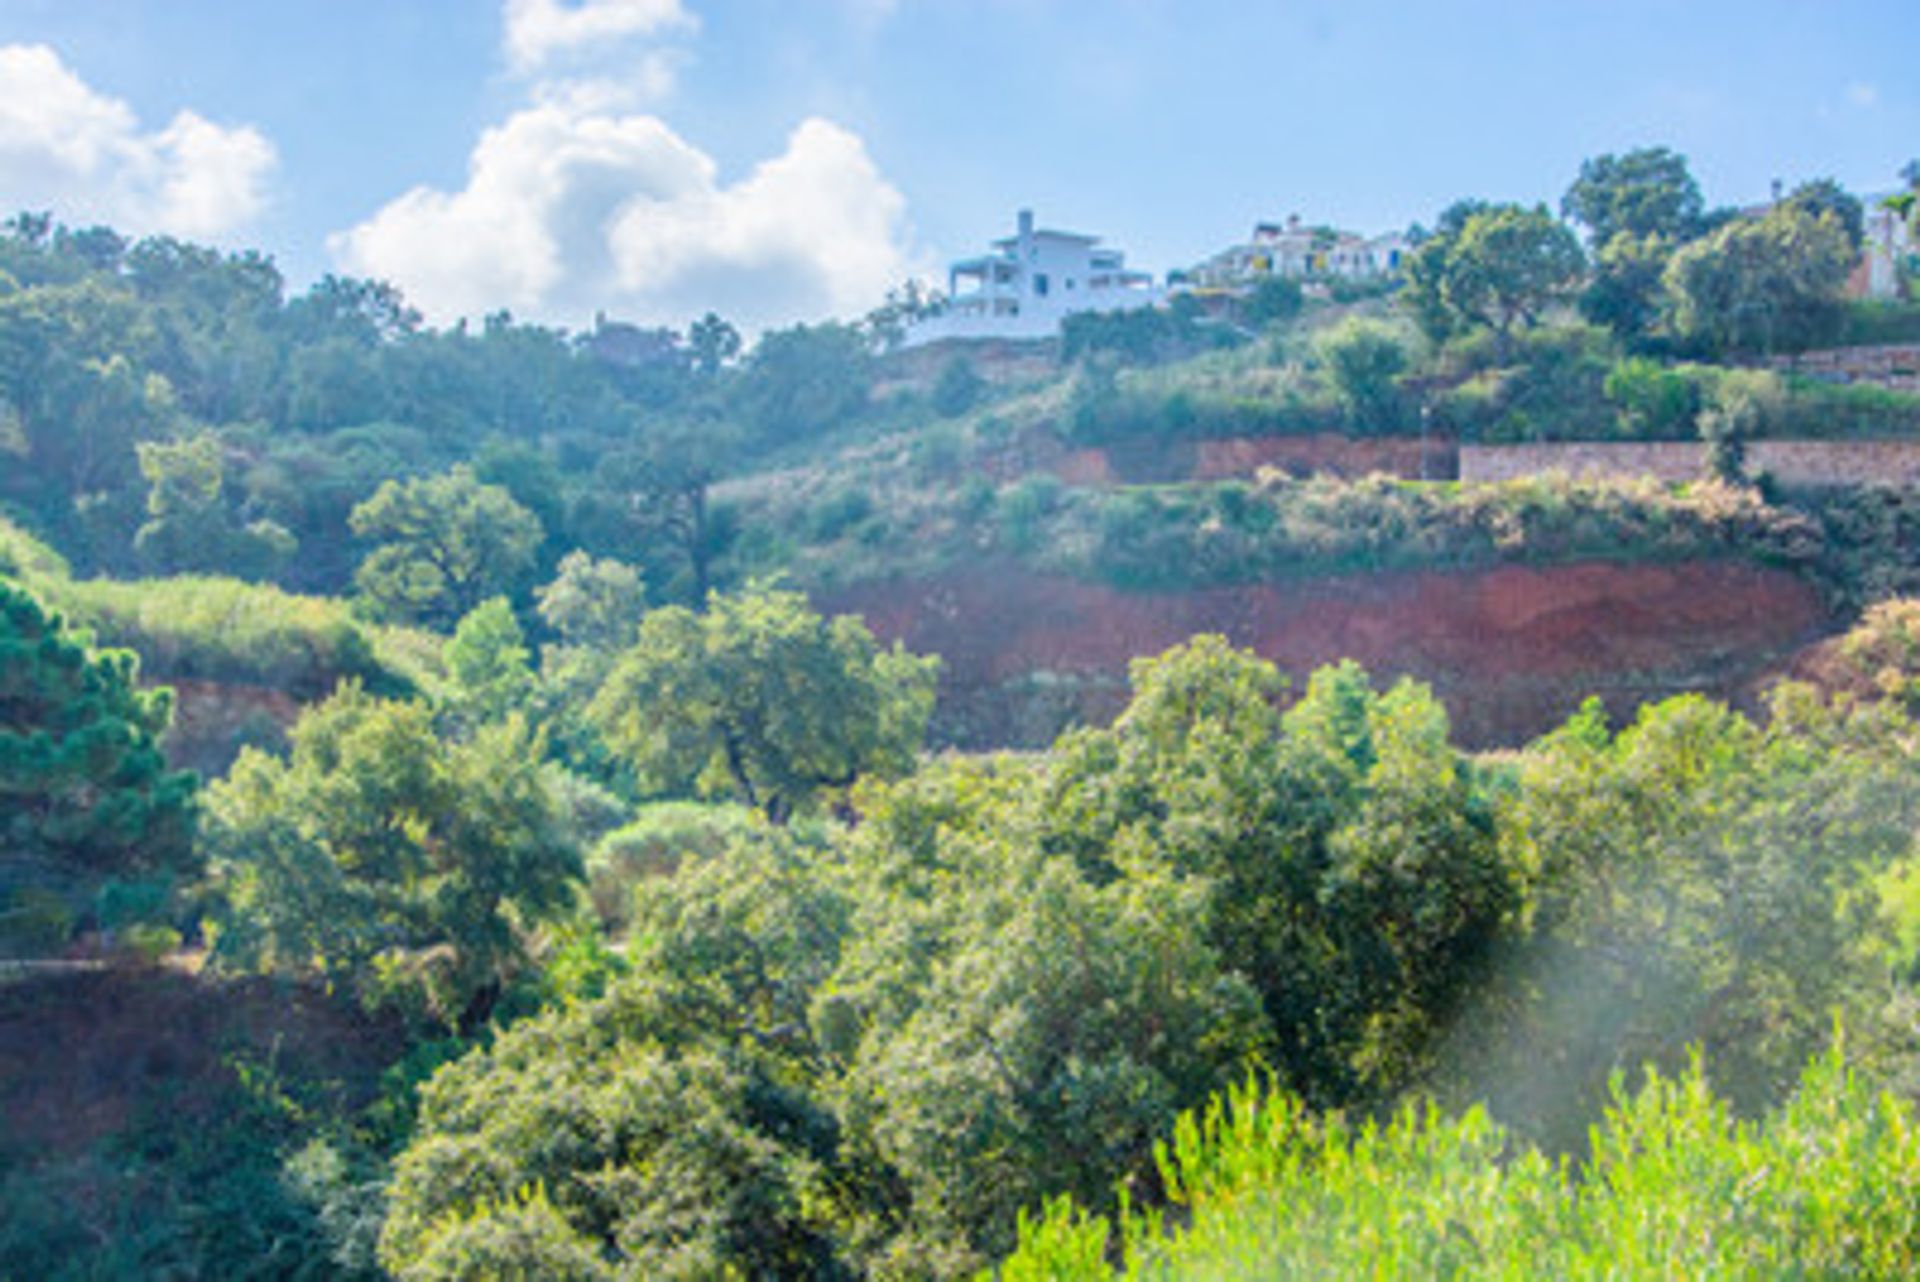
[1407,205,1586,347]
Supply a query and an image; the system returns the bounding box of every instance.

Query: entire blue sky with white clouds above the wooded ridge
[0,0,1920,324]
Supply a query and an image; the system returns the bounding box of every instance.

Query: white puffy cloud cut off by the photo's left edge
[0,44,275,238]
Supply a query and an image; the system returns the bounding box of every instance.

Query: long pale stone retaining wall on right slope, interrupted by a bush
[1459,441,1920,487]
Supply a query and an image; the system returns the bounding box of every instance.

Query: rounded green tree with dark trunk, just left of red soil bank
[589,591,939,821]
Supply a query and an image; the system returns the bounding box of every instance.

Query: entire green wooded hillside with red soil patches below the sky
[11,150,1920,1282]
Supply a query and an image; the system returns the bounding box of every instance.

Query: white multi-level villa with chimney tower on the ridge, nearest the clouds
[906,209,1164,345]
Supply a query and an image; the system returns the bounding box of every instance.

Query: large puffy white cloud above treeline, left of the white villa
[328,100,914,328]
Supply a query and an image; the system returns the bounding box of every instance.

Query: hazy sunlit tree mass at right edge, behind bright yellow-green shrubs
[1457,687,1920,1144]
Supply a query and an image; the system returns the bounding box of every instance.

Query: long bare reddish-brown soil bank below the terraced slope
[822,560,1830,747]
